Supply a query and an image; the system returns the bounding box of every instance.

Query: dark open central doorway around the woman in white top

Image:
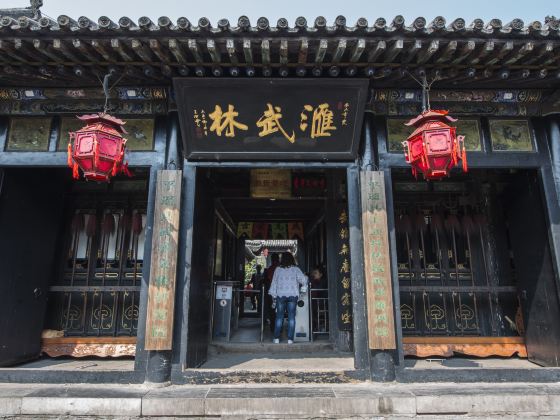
[187,168,352,367]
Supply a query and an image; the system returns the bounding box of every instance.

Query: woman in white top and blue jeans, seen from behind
[268,252,307,344]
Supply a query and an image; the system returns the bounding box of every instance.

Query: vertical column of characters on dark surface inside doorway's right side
[336,202,352,331]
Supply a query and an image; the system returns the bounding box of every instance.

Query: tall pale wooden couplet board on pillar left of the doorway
[145,170,182,350]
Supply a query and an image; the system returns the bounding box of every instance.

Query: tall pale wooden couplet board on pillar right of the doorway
[360,171,395,350]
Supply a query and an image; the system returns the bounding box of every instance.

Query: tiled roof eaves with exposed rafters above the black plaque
[0,9,560,87]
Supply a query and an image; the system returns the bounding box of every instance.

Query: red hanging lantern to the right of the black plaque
[403,110,467,180]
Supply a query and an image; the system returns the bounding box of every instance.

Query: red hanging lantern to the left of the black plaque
[68,113,132,182]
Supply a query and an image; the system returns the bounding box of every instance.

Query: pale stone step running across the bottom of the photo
[0,383,560,420]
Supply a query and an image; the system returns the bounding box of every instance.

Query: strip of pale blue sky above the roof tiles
[4,0,560,26]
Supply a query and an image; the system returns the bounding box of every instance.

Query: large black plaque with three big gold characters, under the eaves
[174,78,368,160]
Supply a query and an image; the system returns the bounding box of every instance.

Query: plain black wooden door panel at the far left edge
[0,169,68,366]
